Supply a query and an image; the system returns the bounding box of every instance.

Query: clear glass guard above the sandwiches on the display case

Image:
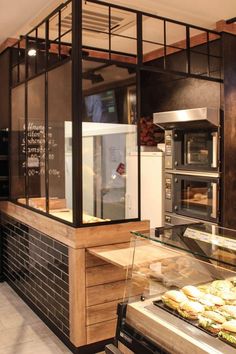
[125,223,236,301]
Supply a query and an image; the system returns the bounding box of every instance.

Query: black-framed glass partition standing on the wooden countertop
[11,0,222,227]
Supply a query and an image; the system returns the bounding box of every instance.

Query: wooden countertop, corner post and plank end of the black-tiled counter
[0,202,149,353]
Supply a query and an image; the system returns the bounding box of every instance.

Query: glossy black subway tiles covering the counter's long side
[1,214,69,337]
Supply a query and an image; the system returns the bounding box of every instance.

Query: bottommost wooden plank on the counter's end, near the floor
[87,320,116,344]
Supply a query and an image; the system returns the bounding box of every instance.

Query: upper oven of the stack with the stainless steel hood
[154,108,220,172]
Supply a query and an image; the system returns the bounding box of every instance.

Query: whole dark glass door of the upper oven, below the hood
[174,130,218,171]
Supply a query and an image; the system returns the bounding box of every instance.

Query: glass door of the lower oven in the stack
[174,175,219,222]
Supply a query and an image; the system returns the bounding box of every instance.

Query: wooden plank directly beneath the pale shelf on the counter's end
[86,264,126,287]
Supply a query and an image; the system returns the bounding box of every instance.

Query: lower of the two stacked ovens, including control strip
[165,173,219,223]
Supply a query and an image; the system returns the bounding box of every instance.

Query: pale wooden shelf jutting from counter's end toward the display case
[88,240,180,268]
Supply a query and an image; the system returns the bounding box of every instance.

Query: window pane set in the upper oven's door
[185,133,210,165]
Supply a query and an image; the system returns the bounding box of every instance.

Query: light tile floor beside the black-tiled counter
[0,283,104,354]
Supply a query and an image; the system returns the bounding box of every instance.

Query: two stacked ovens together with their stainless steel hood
[154,108,220,224]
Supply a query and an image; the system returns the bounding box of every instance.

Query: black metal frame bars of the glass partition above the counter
[10,0,223,227]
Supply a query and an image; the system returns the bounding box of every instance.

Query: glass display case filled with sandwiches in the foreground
[117,223,236,354]
